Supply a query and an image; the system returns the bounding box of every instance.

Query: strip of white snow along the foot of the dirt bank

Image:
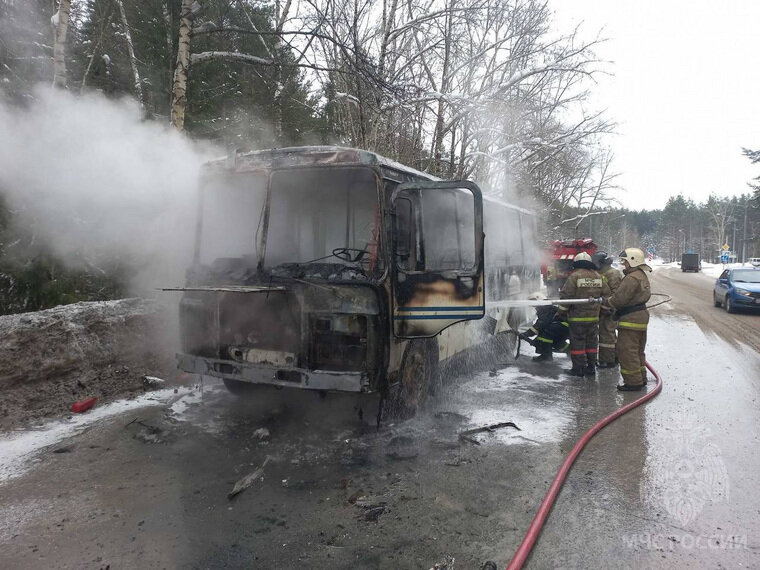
[0,388,199,483]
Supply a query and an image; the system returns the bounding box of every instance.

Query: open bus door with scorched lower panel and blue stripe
[391,181,485,338]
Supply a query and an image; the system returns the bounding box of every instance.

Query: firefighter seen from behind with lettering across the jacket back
[559,251,610,377]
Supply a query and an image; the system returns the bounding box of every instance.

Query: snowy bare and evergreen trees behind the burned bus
[0,0,760,314]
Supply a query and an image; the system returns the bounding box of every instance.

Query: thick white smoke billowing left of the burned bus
[0,87,218,294]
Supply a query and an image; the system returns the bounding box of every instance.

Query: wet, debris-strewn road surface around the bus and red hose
[0,268,760,570]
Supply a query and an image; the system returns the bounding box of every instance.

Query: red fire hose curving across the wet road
[507,362,662,570]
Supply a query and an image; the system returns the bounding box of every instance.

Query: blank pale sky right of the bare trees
[551,0,760,209]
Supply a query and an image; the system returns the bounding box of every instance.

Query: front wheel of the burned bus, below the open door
[391,339,438,418]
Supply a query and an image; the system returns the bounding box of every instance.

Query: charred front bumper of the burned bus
[177,353,372,392]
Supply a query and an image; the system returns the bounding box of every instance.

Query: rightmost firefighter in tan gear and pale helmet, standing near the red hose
[602,247,652,392]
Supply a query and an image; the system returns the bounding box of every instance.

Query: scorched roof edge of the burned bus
[202,146,533,215]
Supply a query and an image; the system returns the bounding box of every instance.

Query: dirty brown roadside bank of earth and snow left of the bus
[0,299,175,427]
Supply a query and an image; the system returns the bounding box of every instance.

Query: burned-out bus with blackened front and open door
[172,147,540,412]
